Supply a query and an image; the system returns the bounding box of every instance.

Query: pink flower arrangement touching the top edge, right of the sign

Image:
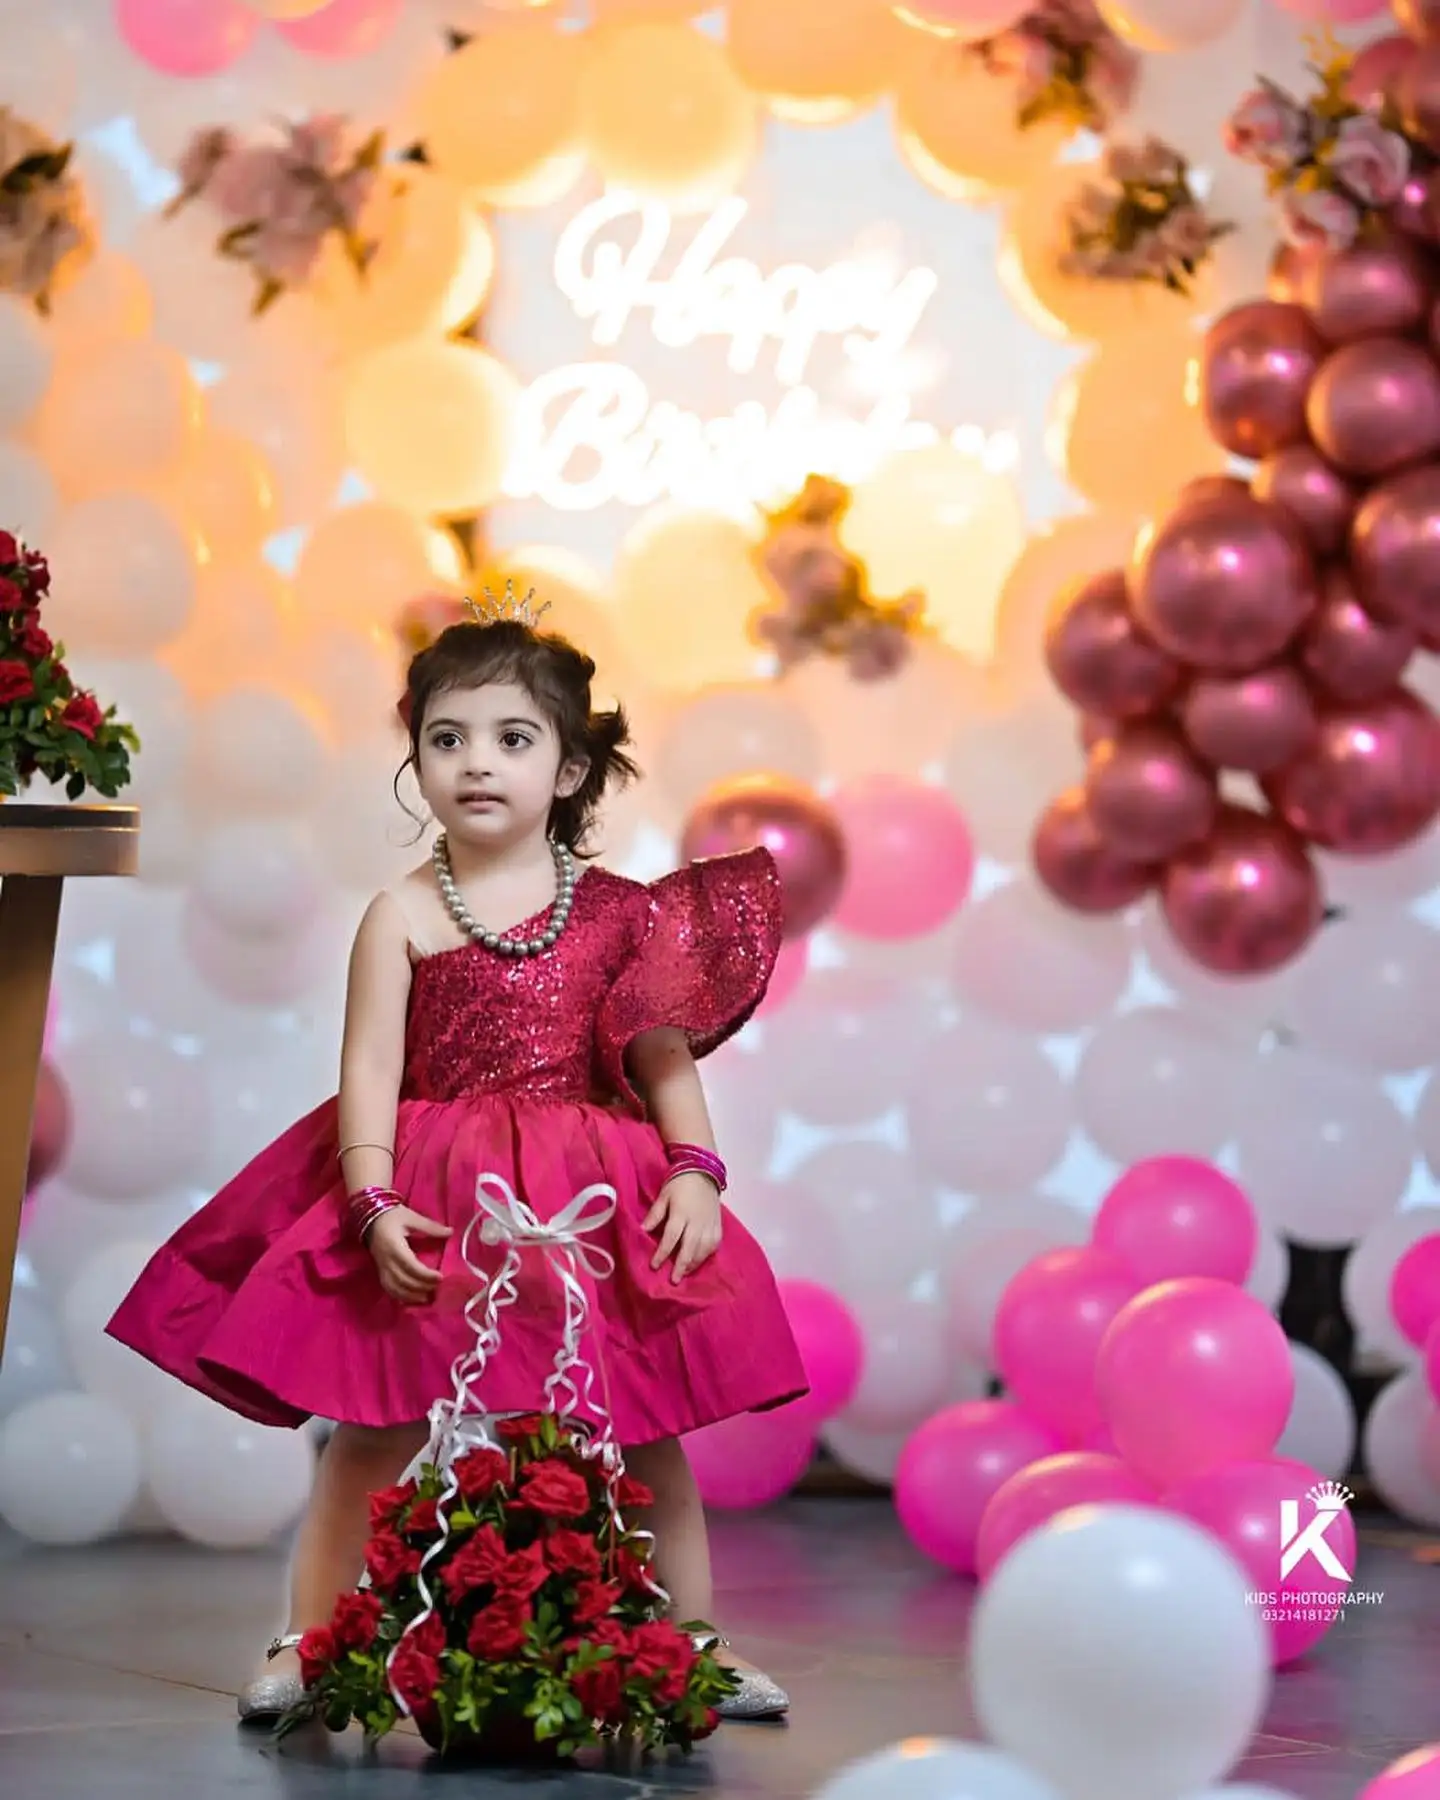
[963,0,1139,131]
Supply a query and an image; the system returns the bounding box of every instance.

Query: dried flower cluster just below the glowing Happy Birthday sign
[751,475,925,680]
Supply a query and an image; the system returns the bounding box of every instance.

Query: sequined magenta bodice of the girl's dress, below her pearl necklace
[401,868,648,1103]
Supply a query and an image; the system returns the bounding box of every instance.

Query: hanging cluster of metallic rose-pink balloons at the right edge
[1033,230,1440,976]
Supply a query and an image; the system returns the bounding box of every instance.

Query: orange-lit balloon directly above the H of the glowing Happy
[580,22,760,205]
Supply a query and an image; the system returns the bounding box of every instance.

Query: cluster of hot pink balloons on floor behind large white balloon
[895,1157,1355,1663]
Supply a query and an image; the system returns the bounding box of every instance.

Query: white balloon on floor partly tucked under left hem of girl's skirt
[146,1393,315,1550]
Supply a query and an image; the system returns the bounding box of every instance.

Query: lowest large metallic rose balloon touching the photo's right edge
[1264,688,1440,857]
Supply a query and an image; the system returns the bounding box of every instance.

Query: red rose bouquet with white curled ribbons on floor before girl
[279,1413,734,1757]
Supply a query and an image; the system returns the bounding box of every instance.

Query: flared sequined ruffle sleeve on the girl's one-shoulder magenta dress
[596,850,781,1105]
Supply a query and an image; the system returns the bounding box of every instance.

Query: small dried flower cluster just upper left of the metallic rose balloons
[1060,137,1235,293]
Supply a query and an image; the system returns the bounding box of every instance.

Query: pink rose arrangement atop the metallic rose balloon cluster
[1226,45,1417,250]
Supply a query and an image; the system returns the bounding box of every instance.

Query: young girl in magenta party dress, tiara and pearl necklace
[110,601,806,1719]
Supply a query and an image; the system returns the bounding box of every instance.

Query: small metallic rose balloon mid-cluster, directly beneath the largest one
[1085,724,1217,862]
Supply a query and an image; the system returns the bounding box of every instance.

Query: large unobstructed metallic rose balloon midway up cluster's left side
[1130,497,1316,675]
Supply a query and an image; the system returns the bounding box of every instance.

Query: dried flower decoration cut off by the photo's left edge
[0,106,95,313]
